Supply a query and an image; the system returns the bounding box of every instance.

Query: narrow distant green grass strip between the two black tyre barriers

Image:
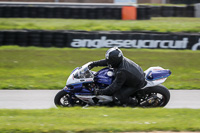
[0,18,200,32]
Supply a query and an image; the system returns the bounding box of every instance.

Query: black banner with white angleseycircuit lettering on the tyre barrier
[69,33,200,50]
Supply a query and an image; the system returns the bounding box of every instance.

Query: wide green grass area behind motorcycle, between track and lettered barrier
[0,46,200,89]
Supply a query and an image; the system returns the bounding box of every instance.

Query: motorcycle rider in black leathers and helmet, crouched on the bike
[88,47,146,106]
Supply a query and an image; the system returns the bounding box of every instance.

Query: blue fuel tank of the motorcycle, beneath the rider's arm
[94,68,114,85]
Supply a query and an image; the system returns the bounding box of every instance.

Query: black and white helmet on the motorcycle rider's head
[105,47,123,68]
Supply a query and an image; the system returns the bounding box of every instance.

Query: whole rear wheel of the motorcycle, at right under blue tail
[140,85,170,107]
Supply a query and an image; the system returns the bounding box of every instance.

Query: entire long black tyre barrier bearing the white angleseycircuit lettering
[0,30,200,50]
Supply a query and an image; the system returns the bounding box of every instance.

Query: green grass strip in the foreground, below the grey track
[0,107,200,133]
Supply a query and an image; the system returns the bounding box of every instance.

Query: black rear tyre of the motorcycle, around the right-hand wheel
[141,85,170,107]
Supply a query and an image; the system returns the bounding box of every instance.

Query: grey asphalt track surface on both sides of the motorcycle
[0,90,200,109]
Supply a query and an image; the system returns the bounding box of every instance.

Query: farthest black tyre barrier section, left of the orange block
[0,5,131,19]
